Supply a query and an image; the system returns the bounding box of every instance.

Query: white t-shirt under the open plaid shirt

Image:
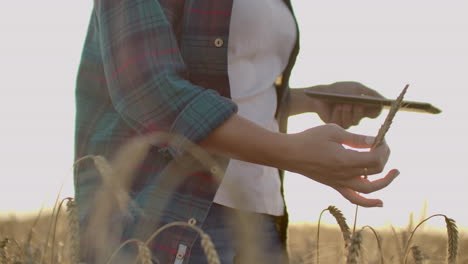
[214,0,297,215]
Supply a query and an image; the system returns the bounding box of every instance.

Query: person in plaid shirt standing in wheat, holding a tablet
[75,0,398,263]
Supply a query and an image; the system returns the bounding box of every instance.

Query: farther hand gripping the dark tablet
[290,82,384,129]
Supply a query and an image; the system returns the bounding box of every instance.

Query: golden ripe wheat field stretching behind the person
[0,209,468,264]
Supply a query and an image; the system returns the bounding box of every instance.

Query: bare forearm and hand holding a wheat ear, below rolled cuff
[200,114,399,207]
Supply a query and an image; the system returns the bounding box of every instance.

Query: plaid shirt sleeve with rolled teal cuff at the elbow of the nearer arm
[95,0,237,153]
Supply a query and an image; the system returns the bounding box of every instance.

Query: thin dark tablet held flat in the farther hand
[305,90,442,114]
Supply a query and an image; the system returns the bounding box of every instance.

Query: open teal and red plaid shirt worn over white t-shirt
[75,0,299,263]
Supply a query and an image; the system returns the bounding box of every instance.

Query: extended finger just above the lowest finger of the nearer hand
[341,170,400,193]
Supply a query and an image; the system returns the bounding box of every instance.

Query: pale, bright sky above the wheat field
[0,0,468,227]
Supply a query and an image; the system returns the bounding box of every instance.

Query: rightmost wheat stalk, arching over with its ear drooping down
[403,214,458,264]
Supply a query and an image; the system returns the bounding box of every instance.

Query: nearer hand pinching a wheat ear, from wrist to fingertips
[281,124,399,207]
